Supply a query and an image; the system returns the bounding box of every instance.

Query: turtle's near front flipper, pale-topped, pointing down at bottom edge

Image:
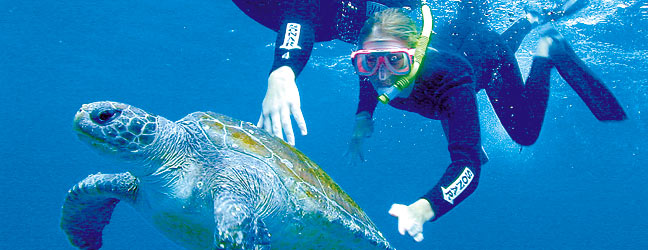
[214,199,270,250]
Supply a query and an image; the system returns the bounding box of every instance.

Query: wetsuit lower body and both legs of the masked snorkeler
[431,1,626,146]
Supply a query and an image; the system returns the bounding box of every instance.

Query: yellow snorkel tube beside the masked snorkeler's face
[378,0,434,104]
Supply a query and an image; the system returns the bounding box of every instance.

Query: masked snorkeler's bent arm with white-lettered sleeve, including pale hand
[389,74,481,241]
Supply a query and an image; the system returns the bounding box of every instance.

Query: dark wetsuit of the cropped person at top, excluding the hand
[233,0,415,76]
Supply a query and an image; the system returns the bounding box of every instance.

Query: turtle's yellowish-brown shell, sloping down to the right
[194,112,380,238]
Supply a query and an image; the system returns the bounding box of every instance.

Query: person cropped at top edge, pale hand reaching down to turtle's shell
[233,0,418,145]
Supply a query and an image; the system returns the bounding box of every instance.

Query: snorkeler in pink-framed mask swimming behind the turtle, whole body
[349,1,625,241]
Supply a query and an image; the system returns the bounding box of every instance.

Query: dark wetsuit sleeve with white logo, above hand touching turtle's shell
[270,0,318,76]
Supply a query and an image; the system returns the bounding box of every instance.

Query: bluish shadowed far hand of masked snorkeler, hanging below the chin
[344,111,373,165]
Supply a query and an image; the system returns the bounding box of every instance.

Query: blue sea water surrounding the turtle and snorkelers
[0,0,648,250]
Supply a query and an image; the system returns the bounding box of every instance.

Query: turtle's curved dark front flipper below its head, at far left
[61,173,137,249]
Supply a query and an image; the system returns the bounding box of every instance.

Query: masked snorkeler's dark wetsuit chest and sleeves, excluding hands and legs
[358,49,481,220]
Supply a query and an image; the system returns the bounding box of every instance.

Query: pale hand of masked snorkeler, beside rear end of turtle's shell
[389,199,434,242]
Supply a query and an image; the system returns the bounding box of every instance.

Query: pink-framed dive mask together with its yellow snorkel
[351,0,434,104]
